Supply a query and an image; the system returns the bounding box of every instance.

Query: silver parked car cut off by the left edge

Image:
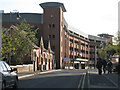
[0,61,18,90]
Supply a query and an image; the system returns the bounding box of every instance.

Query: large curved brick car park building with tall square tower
[2,2,112,69]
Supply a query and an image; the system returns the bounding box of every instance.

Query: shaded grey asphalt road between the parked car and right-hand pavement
[19,70,88,88]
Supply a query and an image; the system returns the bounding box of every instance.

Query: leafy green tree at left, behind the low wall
[2,20,38,64]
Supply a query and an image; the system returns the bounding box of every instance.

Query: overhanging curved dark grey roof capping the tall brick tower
[39,2,66,12]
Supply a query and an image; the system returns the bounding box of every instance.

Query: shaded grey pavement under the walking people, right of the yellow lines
[88,69,120,89]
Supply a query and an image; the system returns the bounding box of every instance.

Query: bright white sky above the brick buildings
[0,0,120,35]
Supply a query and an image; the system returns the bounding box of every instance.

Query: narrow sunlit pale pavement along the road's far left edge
[18,69,61,79]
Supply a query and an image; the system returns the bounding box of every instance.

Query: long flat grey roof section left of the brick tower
[2,13,43,24]
